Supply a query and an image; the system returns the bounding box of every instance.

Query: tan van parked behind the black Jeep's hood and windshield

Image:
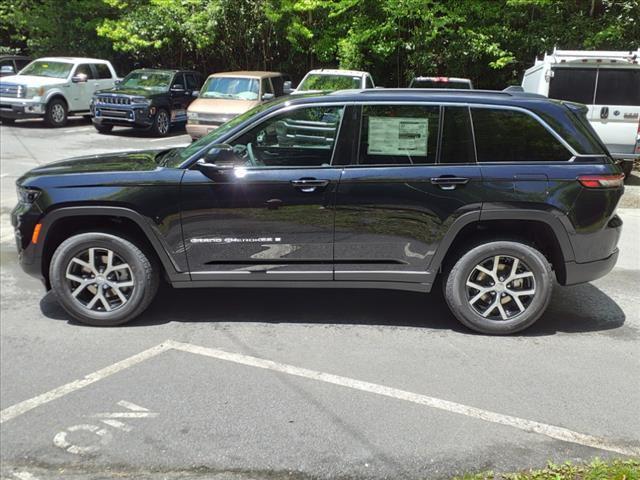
[187,71,291,140]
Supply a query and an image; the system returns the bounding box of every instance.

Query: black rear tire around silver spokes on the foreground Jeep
[444,241,553,335]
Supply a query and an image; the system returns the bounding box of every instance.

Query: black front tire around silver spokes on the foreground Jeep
[49,232,160,326]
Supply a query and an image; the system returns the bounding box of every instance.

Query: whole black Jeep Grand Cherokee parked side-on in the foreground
[12,89,623,334]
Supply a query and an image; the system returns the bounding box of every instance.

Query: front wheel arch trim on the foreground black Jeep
[34,206,190,282]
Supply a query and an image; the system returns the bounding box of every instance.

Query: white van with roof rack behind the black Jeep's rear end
[522,48,640,173]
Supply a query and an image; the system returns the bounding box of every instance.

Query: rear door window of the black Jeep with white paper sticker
[358,105,440,165]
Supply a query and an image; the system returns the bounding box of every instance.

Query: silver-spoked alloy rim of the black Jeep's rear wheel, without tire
[466,255,536,321]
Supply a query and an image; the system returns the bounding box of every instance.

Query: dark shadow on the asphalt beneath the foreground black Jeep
[40,284,626,337]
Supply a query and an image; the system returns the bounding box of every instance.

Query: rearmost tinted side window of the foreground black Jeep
[471,108,572,162]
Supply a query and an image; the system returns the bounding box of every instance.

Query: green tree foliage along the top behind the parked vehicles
[0,0,640,88]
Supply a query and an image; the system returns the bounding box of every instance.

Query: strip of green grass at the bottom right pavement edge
[454,459,640,480]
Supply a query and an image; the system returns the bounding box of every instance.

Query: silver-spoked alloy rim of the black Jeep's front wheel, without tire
[65,247,135,312]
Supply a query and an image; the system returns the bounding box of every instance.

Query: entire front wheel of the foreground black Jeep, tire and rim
[49,232,159,326]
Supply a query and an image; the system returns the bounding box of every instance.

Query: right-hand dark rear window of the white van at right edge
[595,68,640,105]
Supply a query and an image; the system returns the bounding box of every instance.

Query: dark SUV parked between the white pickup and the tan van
[91,69,202,136]
